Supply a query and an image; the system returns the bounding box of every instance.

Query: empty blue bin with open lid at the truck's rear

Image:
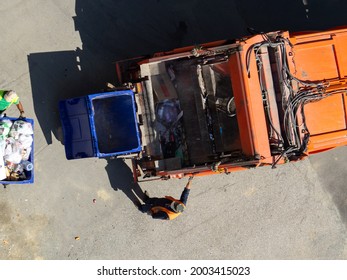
[59,90,142,159]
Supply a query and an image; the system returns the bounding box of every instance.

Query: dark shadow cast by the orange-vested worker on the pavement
[105,159,145,207]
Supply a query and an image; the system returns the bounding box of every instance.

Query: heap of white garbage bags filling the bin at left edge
[0,119,34,181]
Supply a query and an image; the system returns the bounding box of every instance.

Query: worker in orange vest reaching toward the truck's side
[139,176,193,220]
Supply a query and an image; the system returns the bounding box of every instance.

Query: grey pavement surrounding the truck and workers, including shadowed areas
[0,0,347,259]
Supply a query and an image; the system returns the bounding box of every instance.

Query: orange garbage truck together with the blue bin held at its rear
[59,28,347,180]
